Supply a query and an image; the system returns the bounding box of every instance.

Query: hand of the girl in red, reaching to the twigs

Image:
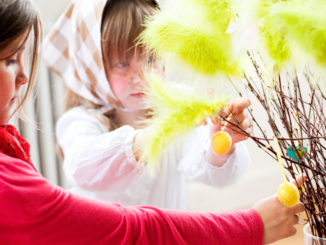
[253,176,306,244]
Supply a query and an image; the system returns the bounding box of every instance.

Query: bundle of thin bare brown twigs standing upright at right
[229,53,326,237]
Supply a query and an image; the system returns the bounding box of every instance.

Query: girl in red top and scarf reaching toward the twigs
[0,0,304,245]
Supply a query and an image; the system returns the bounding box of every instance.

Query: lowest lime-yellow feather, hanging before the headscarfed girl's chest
[141,74,228,164]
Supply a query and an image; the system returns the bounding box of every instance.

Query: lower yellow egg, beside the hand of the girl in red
[277,182,300,207]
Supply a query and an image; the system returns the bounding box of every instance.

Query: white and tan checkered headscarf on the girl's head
[43,0,118,110]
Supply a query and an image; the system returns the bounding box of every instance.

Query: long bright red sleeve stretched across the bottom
[0,154,263,245]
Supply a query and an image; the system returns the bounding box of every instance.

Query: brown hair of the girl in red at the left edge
[0,0,42,119]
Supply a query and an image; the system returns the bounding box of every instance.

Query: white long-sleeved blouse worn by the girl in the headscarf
[56,107,250,209]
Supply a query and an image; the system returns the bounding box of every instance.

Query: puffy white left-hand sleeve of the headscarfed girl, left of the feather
[56,108,142,191]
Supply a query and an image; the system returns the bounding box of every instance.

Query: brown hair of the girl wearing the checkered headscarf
[66,0,158,130]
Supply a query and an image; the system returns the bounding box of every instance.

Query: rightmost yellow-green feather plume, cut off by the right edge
[270,0,326,66]
